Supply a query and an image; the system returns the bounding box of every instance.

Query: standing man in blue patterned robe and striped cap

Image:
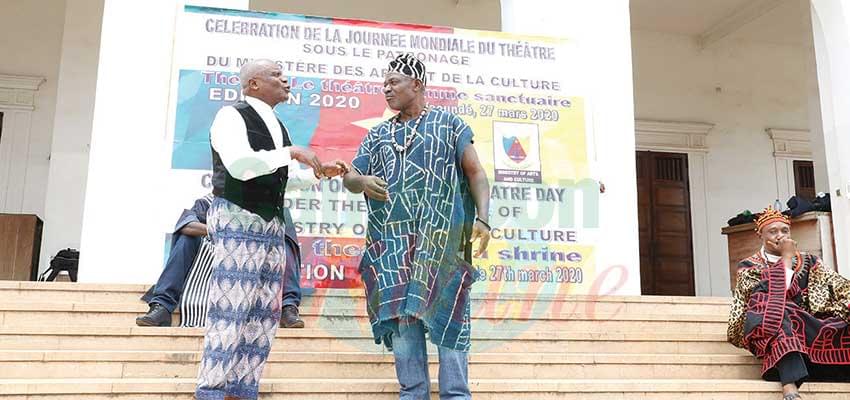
[344,54,490,400]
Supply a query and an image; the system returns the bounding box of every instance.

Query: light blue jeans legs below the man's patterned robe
[392,318,472,400]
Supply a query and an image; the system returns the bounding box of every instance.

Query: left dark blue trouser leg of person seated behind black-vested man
[148,233,201,312]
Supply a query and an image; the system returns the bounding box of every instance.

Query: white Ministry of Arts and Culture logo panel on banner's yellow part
[493,121,542,183]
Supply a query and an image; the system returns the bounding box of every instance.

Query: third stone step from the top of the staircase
[0,326,748,355]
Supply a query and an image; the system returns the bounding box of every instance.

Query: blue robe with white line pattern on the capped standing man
[352,109,475,351]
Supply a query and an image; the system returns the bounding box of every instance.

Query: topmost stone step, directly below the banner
[0,281,729,315]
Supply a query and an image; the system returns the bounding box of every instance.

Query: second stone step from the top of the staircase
[0,302,727,333]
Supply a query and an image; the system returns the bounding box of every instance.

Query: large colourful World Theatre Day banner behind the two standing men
[164,6,599,294]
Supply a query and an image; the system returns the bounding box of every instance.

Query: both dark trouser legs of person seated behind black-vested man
[146,233,301,312]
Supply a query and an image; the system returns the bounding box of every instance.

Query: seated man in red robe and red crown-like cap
[727,207,850,400]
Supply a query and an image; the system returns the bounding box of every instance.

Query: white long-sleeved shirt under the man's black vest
[210,96,296,180]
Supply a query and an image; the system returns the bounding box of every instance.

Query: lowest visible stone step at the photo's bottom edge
[0,378,850,400]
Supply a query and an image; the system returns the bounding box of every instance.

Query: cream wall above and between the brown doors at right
[632,27,810,296]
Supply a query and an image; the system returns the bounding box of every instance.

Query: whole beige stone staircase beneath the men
[0,281,850,400]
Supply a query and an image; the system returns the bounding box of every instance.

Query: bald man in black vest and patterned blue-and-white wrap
[195,60,347,400]
